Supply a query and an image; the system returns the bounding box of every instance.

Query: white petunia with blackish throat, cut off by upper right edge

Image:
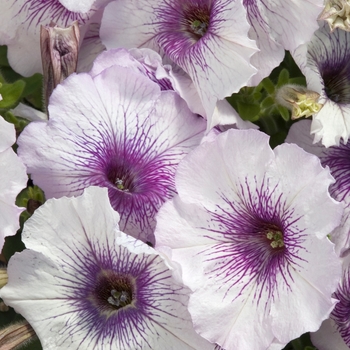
[292,24,350,147]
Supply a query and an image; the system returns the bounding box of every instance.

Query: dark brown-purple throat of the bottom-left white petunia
[91,270,135,314]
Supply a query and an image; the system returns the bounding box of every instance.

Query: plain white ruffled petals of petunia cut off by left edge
[0,116,28,252]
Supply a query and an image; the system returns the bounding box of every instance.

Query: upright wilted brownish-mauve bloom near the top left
[40,21,80,114]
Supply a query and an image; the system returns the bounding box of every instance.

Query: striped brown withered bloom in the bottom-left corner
[0,321,37,350]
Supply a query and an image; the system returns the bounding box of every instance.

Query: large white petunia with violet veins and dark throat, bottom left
[0,188,214,350]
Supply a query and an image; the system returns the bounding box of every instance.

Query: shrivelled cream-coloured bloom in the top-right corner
[318,0,350,32]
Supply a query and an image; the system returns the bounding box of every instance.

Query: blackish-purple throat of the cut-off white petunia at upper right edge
[321,57,350,104]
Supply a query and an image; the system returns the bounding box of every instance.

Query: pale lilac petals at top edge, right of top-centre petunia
[243,0,323,85]
